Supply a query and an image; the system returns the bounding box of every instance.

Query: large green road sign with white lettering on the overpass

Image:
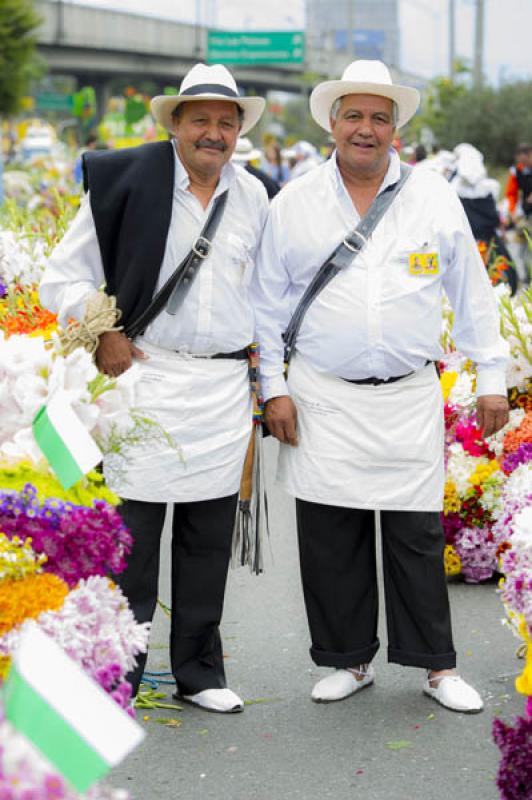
[207,31,305,64]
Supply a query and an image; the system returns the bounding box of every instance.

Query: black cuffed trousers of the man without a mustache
[296,499,456,669]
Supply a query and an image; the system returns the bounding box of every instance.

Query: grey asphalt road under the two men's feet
[109,440,523,800]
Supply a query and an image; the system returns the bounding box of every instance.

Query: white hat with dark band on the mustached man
[150,64,266,134]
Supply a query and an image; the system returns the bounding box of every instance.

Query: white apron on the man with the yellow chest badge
[277,354,444,511]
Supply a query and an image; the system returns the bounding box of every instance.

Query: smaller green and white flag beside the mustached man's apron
[32,391,103,489]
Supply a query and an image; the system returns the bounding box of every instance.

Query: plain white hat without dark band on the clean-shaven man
[310,60,420,131]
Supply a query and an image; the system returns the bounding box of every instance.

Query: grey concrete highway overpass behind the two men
[35,0,424,115]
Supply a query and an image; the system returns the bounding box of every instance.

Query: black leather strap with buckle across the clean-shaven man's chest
[283,164,412,366]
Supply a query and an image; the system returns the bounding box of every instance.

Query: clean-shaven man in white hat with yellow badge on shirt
[253,61,508,712]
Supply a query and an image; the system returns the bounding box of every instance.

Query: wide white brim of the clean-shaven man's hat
[310,81,421,133]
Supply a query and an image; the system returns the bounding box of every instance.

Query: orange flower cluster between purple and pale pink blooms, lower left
[0,573,69,636]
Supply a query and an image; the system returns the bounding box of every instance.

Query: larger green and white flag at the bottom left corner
[3,624,144,792]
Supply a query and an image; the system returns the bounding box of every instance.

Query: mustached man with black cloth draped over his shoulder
[40,64,268,713]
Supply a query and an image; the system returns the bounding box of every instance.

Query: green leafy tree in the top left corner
[0,0,43,114]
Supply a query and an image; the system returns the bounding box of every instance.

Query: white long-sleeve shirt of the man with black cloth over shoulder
[40,149,268,354]
